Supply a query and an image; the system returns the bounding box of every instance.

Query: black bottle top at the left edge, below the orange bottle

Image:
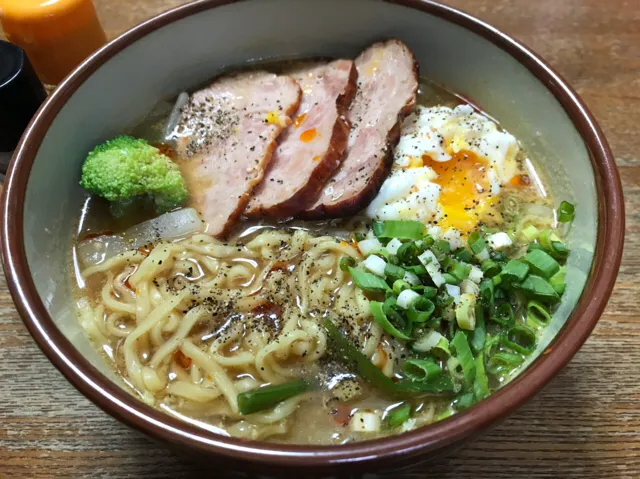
[0,40,47,156]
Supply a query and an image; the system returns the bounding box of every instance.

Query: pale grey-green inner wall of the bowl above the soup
[24,0,598,432]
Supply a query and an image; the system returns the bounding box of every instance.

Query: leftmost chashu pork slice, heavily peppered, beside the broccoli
[175,71,301,238]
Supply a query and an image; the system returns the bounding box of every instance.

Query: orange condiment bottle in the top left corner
[0,0,107,85]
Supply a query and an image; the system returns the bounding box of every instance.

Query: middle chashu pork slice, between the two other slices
[245,60,357,218]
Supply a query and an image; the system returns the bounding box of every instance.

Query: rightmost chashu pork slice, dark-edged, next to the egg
[300,39,418,219]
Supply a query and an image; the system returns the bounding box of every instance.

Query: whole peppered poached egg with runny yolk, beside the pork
[367,105,519,234]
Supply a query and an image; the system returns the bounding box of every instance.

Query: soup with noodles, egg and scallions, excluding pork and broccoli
[73,52,570,444]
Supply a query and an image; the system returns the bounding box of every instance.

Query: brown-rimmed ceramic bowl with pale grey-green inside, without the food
[2,0,624,472]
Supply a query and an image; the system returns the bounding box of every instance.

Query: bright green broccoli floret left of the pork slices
[80,136,188,213]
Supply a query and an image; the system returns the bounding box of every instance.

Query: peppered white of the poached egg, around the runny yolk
[367,105,519,232]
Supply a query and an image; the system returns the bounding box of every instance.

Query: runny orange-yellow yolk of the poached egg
[422,150,496,233]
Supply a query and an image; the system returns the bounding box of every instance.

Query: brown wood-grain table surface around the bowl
[0,0,640,479]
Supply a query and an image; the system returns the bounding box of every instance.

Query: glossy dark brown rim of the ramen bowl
[1,0,625,468]
